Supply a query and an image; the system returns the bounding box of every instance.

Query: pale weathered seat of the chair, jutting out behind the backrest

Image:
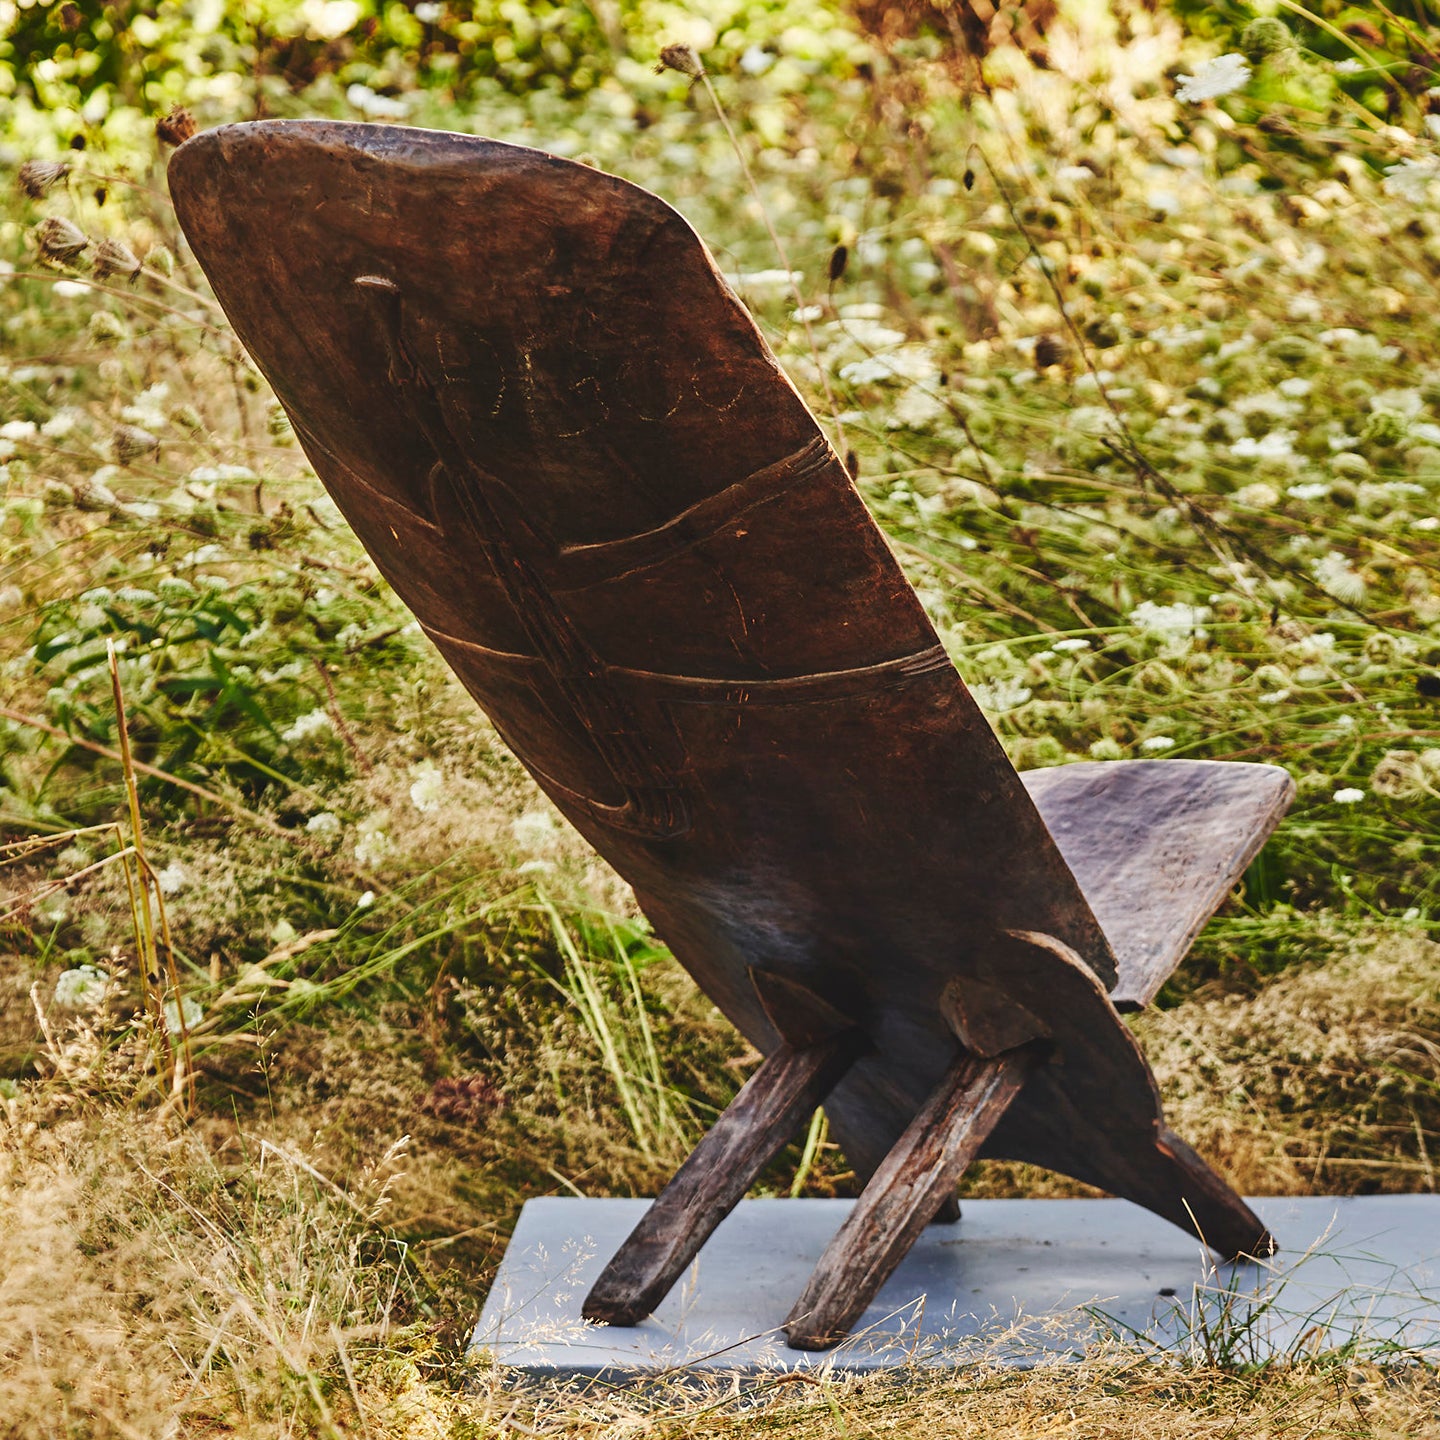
[1021,760,1295,1011]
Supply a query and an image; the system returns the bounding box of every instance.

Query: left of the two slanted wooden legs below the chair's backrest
[582,1030,864,1325]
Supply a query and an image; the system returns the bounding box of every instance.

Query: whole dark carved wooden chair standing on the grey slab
[170,121,1292,1349]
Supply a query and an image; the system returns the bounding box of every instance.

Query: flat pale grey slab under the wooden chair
[471,1195,1440,1382]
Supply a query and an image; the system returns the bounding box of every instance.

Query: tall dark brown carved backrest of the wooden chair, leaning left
[170,121,1115,1172]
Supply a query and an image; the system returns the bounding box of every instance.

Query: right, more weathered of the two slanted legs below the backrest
[785,1045,1040,1349]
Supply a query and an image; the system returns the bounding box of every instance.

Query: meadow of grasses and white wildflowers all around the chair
[0,0,1440,1440]
